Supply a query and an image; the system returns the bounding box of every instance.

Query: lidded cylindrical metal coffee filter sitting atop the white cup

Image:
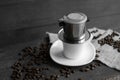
[58,13,87,43]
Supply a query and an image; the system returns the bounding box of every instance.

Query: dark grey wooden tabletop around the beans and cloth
[0,0,120,80]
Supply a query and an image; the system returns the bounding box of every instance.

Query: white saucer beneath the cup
[50,40,96,66]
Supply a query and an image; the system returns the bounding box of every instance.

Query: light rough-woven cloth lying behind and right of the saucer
[46,27,120,70]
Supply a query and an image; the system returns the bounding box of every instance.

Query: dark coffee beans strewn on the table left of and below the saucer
[11,38,102,80]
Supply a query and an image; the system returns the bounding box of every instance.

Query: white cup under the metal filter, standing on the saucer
[63,35,93,59]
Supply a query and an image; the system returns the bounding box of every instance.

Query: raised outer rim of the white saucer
[50,40,96,66]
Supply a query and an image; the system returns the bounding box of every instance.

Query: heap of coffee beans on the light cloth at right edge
[98,32,120,52]
